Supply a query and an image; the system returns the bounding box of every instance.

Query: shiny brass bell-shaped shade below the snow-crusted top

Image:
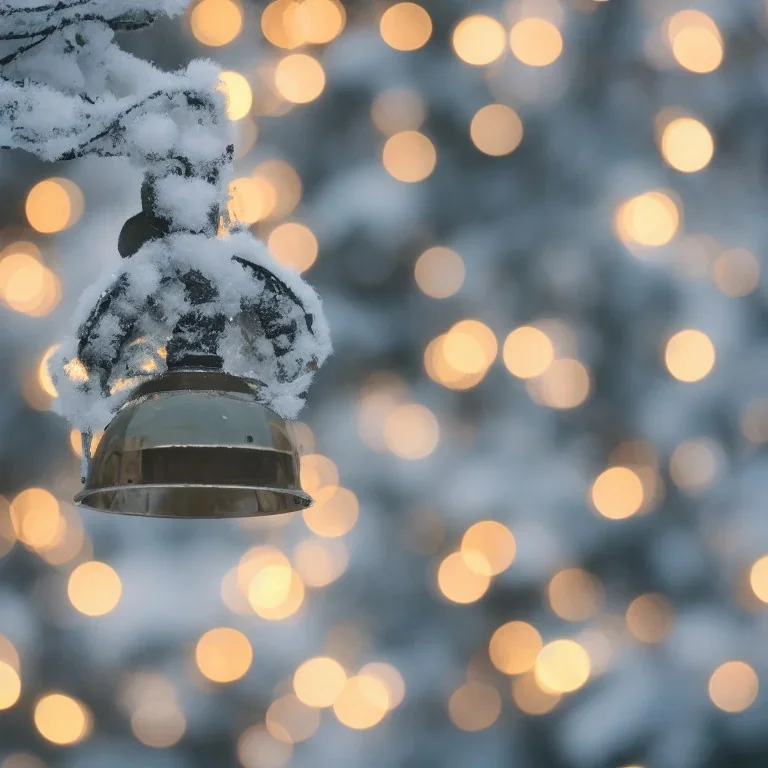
[75,369,312,518]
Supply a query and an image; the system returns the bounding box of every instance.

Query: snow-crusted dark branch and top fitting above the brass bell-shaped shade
[0,0,331,431]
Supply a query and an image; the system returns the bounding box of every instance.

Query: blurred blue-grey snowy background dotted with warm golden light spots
[0,0,768,768]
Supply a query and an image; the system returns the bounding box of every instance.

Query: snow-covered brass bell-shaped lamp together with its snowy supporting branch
[0,0,330,518]
